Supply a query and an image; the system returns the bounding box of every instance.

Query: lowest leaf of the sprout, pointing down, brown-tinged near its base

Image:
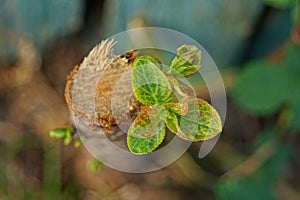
[127,107,166,154]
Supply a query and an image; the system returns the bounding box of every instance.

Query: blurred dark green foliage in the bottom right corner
[215,130,291,200]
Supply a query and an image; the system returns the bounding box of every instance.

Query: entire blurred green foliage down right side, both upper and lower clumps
[214,42,300,199]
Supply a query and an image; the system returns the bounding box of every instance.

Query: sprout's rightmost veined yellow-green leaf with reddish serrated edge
[165,99,222,141]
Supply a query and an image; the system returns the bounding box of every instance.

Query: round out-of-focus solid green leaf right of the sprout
[230,61,289,115]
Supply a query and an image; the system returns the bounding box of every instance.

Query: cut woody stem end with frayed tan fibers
[65,39,140,133]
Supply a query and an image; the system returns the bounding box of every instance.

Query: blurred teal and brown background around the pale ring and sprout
[0,0,300,200]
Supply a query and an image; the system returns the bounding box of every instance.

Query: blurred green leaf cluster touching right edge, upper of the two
[230,43,300,130]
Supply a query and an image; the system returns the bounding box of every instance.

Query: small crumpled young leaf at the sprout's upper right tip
[171,45,201,76]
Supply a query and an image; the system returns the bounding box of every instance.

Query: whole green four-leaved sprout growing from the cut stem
[127,45,222,154]
